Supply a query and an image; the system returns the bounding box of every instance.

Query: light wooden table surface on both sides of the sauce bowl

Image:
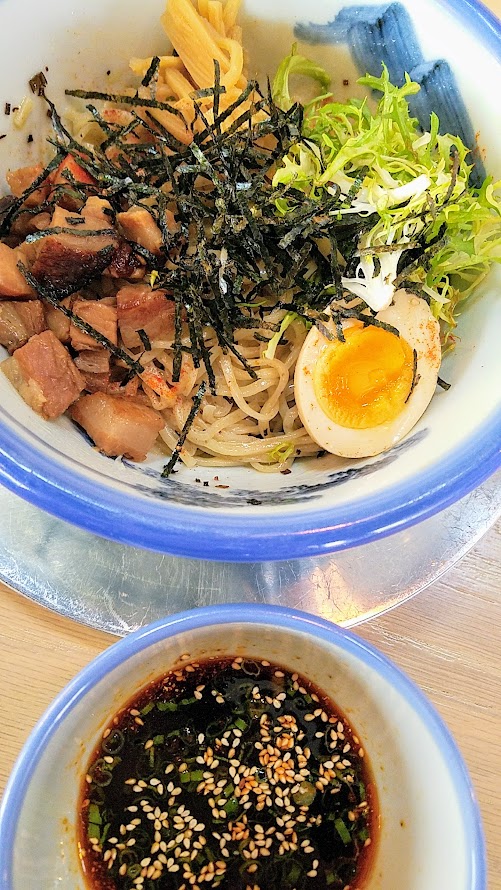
[0,0,501,890]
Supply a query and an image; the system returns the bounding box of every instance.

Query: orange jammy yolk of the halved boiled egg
[313,325,414,430]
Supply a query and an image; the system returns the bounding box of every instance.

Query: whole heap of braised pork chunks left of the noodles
[0,155,174,461]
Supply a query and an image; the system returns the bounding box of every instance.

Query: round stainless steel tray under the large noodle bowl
[0,472,501,636]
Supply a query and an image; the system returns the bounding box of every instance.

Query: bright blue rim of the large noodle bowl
[0,0,501,562]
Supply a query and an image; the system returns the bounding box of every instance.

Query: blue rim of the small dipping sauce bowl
[0,603,487,890]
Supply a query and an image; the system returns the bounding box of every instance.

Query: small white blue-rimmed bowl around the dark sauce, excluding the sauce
[0,605,486,890]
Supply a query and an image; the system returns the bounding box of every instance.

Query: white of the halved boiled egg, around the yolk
[294,290,441,457]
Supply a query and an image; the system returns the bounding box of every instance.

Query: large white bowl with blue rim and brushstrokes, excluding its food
[0,0,501,561]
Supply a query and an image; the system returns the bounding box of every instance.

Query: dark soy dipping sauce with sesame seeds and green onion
[79,657,377,890]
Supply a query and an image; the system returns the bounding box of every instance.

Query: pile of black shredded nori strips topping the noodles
[0,67,452,434]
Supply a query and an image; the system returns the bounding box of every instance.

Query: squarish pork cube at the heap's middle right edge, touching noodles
[117,284,175,349]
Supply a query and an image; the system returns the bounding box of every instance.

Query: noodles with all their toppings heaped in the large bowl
[0,0,501,475]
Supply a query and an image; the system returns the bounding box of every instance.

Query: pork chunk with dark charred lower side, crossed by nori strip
[32,197,118,290]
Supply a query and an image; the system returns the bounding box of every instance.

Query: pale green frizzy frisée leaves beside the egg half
[269,59,501,336]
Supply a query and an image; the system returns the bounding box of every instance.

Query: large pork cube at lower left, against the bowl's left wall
[0,331,84,420]
